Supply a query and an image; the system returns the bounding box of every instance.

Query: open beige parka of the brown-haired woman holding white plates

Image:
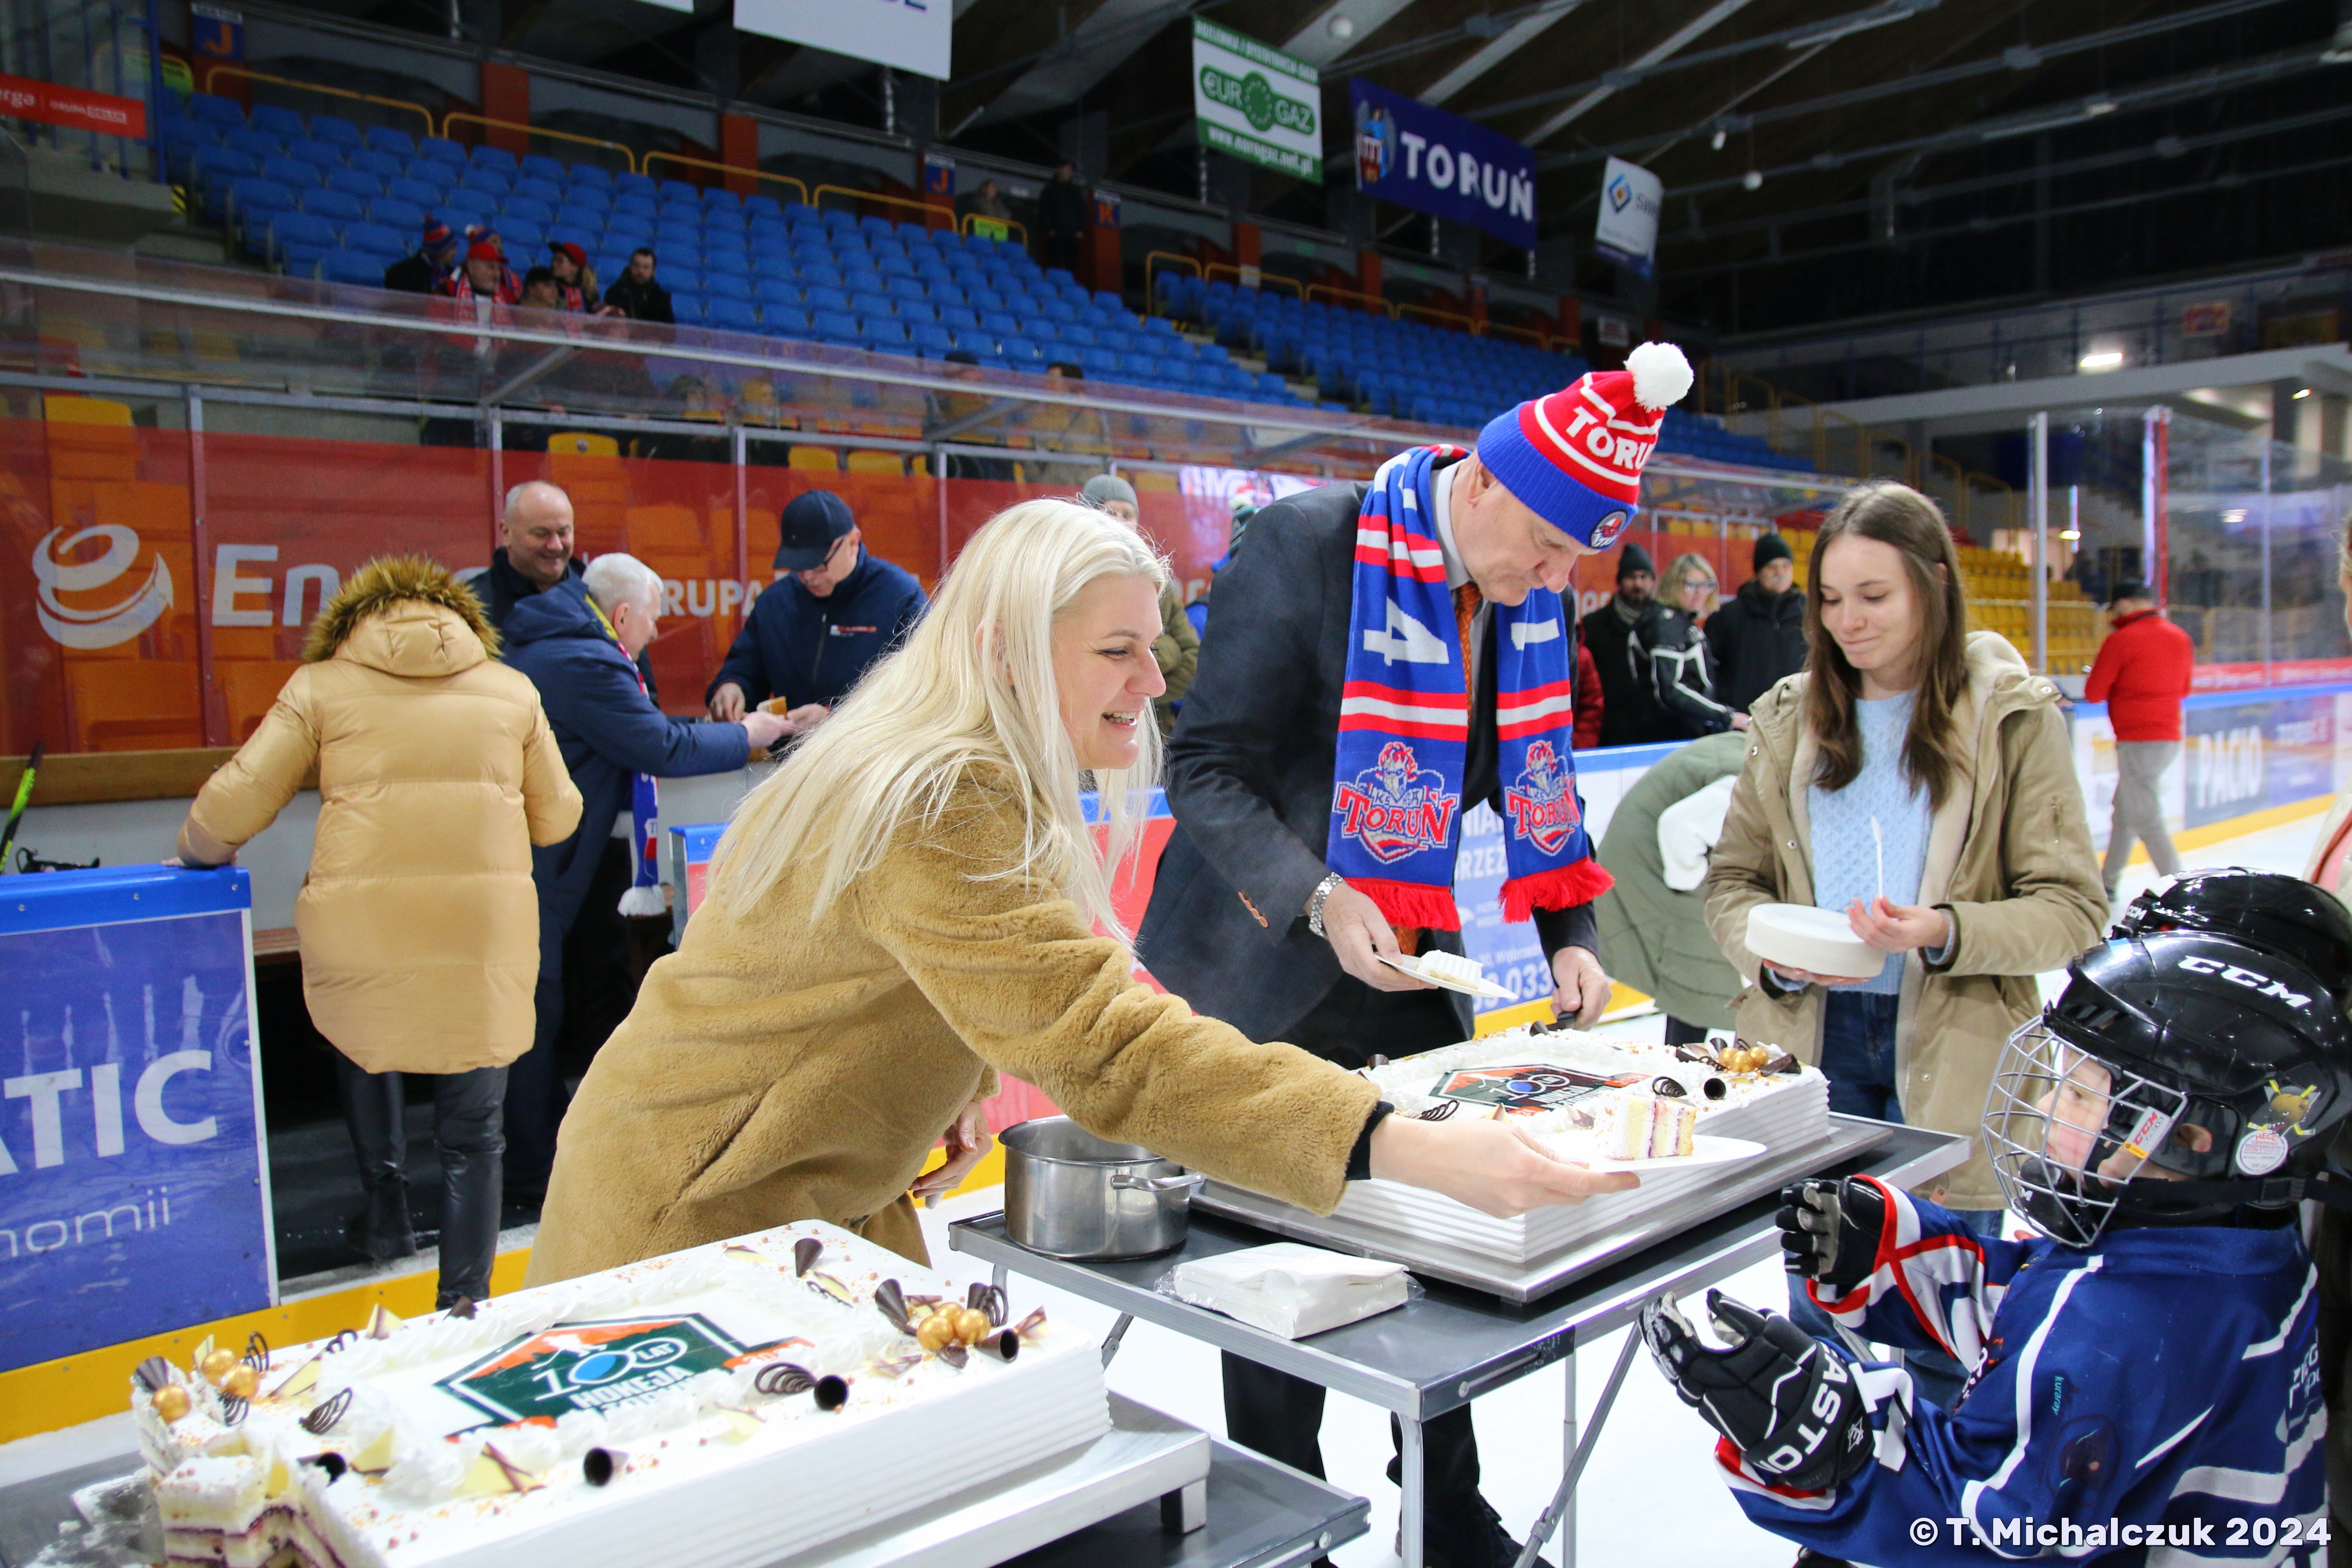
[1703,632,2107,1208]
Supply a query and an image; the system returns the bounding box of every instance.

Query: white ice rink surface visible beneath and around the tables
[924,816,2321,1568]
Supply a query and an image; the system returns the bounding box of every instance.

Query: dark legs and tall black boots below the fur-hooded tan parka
[334,1053,505,1307]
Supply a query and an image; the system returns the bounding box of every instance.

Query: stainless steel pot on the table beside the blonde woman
[1002,1117,1209,1260]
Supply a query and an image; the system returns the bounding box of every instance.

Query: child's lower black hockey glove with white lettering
[1642,1291,1874,1493]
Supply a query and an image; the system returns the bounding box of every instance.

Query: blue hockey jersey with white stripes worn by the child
[1717,1189,2328,1568]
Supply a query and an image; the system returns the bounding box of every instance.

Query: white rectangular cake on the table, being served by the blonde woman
[1336,1027,1830,1262]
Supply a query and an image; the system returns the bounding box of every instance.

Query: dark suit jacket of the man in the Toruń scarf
[1136,482,1597,1039]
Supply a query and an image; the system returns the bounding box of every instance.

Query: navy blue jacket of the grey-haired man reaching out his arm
[505,578,750,976]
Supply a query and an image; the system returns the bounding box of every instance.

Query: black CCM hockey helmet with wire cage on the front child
[1985,931,2352,1246]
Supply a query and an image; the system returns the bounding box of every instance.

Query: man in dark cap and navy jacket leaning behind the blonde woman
[703,489,929,736]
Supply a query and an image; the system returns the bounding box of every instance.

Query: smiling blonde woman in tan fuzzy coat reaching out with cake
[529,501,1632,1283]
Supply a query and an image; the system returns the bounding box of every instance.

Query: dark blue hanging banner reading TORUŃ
[1348,75,1536,249]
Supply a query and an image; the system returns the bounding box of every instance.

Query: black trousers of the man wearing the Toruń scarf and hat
[1223,976,1479,1521]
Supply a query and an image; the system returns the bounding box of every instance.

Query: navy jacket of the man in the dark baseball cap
[703,545,929,707]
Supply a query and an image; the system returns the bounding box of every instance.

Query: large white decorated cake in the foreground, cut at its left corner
[132,1220,1110,1568]
